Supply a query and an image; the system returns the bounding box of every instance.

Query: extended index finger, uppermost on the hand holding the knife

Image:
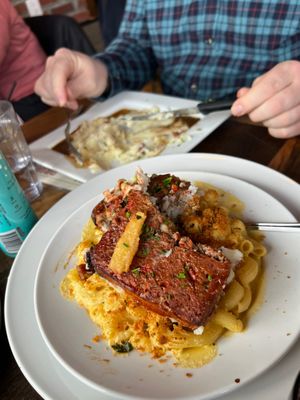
[231,61,300,116]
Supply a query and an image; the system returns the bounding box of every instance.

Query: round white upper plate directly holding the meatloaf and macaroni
[35,170,300,400]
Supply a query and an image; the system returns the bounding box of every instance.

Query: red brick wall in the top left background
[11,0,96,22]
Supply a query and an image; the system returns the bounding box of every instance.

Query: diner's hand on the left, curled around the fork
[34,48,108,109]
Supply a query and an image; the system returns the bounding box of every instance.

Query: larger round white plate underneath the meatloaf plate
[5,154,300,400]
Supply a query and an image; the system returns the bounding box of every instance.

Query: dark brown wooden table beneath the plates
[0,103,300,400]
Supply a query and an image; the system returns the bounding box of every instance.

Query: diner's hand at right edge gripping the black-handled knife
[231,61,300,138]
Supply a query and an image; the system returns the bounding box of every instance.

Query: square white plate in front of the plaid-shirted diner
[30,91,230,182]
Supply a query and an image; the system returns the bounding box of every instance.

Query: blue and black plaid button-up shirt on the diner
[96,0,300,101]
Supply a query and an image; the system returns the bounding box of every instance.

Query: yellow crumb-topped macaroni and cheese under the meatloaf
[61,184,266,368]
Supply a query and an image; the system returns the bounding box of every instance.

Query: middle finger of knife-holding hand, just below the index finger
[249,84,300,122]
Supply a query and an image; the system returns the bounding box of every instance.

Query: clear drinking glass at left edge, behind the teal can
[0,100,43,202]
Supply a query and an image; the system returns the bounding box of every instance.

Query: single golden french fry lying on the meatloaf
[109,211,146,274]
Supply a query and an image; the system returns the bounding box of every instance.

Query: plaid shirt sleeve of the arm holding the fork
[95,0,157,97]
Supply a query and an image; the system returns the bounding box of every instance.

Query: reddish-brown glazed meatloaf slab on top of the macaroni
[87,175,230,329]
